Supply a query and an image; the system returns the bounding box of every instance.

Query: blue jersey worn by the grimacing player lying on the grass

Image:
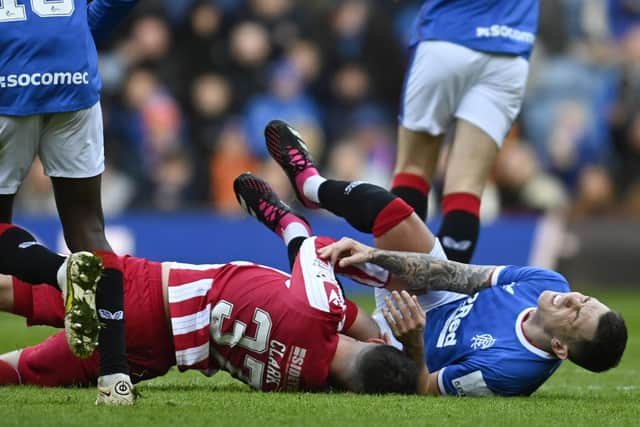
[425,266,569,396]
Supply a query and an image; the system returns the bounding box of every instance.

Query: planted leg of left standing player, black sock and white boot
[52,175,135,405]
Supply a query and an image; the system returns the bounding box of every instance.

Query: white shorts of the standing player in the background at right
[400,41,529,146]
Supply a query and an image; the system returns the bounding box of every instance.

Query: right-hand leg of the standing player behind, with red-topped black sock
[438,119,498,263]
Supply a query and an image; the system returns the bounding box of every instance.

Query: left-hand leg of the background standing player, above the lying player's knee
[391,126,444,221]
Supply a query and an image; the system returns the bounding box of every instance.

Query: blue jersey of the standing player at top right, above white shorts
[410,0,539,58]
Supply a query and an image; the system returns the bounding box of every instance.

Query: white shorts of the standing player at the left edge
[0,102,104,194]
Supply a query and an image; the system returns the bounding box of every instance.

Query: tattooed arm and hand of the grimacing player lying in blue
[319,238,495,295]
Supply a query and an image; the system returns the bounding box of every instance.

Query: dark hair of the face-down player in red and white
[355,345,418,394]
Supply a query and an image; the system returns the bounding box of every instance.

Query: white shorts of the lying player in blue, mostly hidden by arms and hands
[373,238,469,349]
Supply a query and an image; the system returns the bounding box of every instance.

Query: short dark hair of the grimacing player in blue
[569,311,627,372]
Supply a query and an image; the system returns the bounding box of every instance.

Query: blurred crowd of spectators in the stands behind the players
[16,0,640,220]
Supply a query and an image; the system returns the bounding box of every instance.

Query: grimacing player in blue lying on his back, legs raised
[241,121,627,396]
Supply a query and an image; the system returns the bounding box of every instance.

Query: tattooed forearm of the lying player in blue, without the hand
[369,249,495,295]
